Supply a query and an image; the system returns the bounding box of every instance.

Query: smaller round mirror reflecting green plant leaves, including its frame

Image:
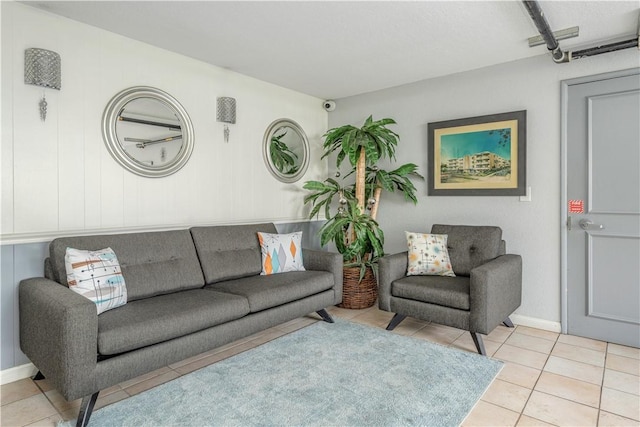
[262,119,309,182]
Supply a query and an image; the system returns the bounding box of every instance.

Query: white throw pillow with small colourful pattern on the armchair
[405,231,455,277]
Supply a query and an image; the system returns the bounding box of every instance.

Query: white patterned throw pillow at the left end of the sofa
[64,248,127,314]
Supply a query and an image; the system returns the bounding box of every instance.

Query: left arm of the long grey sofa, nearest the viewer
[19,277,98,400]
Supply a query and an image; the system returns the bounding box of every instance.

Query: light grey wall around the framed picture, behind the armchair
[329,49,640,329]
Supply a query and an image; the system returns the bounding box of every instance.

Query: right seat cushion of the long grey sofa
[205,271,334,313]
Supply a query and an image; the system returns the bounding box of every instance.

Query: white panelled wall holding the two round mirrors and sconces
[0,2,327,243]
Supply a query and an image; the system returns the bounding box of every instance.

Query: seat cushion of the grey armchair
[391,276,470,310]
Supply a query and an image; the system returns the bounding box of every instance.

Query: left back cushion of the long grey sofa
[49,230,204,301]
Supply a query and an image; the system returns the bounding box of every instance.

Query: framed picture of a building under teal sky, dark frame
[428,110,527,196]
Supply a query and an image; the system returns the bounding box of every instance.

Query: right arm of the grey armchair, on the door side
[469,254,522,334]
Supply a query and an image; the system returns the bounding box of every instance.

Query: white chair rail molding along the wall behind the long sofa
[0,218,324,246]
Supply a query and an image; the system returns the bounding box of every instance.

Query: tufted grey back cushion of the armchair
[431,224,503,276]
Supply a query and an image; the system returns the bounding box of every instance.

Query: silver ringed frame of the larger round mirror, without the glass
[102,86,194,178]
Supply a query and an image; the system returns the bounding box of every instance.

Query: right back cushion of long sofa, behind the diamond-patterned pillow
[191,223,277,284]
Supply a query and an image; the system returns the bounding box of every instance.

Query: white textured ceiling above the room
[23,0,640,99]
